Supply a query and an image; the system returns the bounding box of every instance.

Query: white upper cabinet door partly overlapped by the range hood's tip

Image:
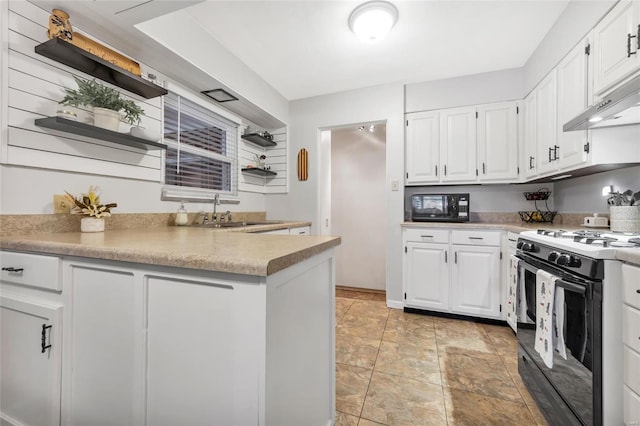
[557,39,589,168]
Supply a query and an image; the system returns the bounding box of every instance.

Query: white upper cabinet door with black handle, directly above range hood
[593,1,640,97]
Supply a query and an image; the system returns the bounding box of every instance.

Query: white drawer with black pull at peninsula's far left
[0,251,62,291]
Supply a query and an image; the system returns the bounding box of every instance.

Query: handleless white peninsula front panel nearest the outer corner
[146,276,262,426]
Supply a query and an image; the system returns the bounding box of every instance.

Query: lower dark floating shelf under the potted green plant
[35,117,166,149]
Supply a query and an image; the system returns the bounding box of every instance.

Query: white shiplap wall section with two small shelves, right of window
[238,126,288,194]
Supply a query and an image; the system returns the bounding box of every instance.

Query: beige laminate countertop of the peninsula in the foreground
[0,226,340,276]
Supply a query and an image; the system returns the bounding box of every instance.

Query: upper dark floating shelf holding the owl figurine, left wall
[35,38,168,99]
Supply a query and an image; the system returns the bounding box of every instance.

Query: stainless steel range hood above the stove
[562,76,640,132]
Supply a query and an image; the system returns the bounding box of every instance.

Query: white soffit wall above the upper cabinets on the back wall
[405,68,524,113]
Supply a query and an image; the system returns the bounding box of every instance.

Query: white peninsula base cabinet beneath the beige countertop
[0,248,335,426]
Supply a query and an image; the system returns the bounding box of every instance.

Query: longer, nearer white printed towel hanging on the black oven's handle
[534,269,558,368]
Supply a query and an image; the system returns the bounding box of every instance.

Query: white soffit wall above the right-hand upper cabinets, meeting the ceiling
[524,0,617,95]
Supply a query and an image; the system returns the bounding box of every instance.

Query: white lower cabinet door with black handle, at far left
[0,296,62,425]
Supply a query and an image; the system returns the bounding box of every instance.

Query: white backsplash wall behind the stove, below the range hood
[555,166,640,213]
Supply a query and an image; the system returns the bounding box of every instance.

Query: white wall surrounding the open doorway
[266,84,404,307]
